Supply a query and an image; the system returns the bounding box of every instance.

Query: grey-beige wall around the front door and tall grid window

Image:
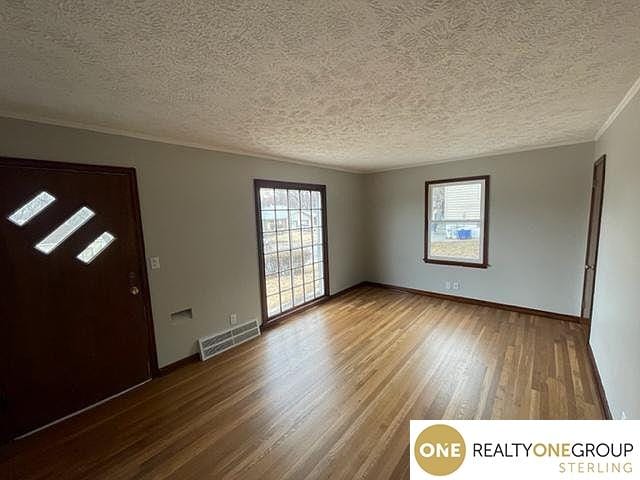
[0,118,364,366]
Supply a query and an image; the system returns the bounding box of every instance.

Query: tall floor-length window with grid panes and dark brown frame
[255,180,329,321]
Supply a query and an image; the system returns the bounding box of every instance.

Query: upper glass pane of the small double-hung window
[430,182,482,220]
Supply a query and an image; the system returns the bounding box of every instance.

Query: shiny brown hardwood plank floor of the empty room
[0,287,601,479]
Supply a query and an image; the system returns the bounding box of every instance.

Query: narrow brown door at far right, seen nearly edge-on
[582,155,606,331]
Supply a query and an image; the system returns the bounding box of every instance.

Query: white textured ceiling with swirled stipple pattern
[0,0,640,170]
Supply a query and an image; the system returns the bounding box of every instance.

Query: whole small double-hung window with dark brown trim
[424,176,489,268]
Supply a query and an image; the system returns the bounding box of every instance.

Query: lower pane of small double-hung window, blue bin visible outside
[429,222,481,261]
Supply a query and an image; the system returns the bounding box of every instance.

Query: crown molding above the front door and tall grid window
[0,110,366,173]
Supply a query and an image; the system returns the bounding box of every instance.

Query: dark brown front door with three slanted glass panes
[0,159,155,439]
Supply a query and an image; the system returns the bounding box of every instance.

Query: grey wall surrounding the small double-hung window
[366,143,594,315]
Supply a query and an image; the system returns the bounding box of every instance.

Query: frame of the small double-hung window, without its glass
[424,175,490,268]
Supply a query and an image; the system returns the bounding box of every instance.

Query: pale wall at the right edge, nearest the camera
[591,91,640,419]
